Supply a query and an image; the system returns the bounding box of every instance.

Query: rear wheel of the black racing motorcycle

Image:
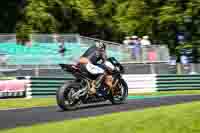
[56,83,78,110]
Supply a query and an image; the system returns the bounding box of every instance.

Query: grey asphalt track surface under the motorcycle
[0,95,200,130]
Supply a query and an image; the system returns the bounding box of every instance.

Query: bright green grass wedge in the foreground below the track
[0,102,200,133]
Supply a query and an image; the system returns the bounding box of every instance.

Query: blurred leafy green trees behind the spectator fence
[14,0,200,53]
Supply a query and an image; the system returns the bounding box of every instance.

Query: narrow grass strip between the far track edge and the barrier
[0,90,200,109]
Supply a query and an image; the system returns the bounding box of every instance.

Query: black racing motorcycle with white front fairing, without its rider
[56,57,128,110]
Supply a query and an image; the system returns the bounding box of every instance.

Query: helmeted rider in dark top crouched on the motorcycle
[79,41,112,94]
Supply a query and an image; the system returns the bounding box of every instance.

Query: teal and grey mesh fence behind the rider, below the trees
[0,34,169,65]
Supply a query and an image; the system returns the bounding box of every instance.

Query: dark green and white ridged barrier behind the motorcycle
[11,74,200,98]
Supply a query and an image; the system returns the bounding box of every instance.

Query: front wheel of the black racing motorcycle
[110,79,128,104]
